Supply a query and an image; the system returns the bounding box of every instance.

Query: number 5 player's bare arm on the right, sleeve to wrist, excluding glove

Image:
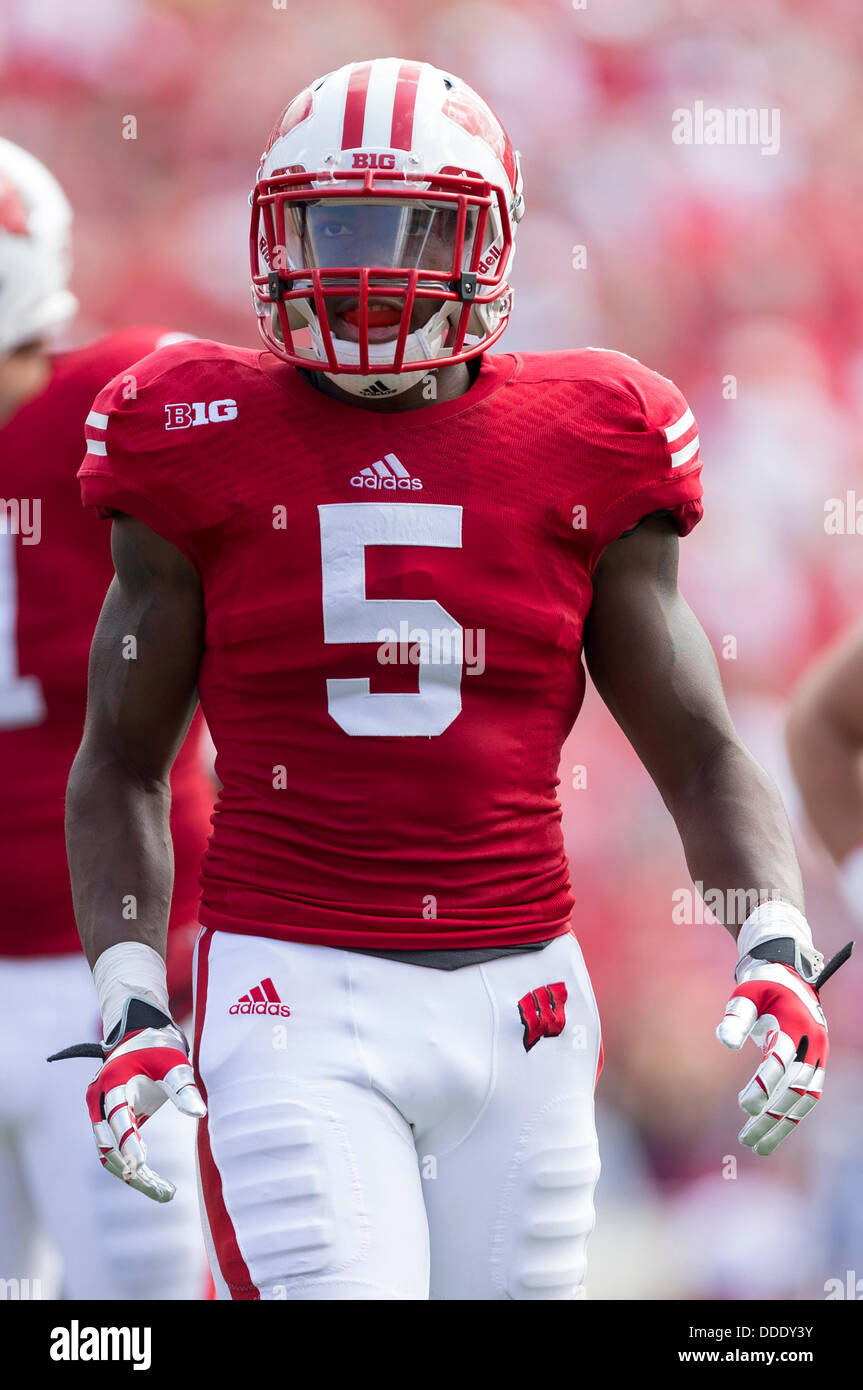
[585,517,803,922]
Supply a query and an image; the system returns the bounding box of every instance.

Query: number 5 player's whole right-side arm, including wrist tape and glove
[585,517,848,1154]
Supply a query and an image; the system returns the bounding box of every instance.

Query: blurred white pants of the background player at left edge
[0,955,207,1300]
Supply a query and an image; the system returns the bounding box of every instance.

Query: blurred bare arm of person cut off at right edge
[787,627,863,867]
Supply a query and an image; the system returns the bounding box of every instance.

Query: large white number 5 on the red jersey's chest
[318,502,464,738]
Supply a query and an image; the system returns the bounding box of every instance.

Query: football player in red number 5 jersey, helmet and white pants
[68,58,850,1300]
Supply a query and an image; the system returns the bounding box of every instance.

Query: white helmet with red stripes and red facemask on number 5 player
[250,58,524,396]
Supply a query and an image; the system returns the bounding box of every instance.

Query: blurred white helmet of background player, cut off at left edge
[0,138,78,354]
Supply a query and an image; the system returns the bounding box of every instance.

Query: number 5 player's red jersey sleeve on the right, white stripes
[580,354,703,564]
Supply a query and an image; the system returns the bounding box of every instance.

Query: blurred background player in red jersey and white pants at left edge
[0,140,213,1298]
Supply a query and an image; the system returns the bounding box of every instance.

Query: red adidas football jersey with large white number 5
[81,342,702,949]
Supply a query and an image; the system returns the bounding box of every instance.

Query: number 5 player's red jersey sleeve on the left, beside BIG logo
[78,348,222,569]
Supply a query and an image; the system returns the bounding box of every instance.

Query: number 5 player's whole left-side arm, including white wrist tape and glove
[58,516,204,1201]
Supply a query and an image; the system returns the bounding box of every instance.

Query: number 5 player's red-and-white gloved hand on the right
[716,942,850,1155]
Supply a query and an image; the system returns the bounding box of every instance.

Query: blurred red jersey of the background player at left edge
[0,328,213,963]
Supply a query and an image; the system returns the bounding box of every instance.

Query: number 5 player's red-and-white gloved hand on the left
[49,997,207,1202]
